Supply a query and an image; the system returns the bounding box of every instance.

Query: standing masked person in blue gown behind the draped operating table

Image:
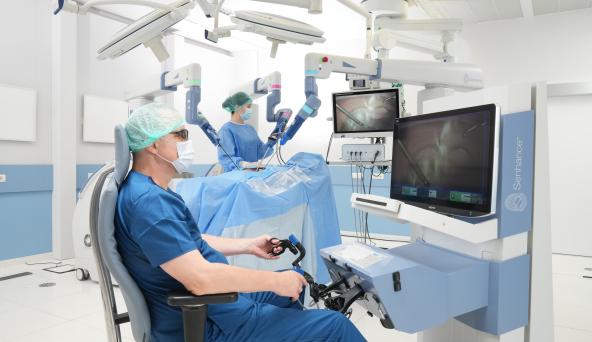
[218,92,277,172]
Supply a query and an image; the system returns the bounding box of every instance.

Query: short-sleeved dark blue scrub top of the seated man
[115,170,255,342]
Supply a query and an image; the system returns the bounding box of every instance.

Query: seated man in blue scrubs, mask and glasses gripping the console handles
[115,104,364,342]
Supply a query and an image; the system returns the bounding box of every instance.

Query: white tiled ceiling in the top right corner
[415,0,592,22]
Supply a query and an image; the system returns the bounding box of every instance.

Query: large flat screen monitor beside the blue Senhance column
[391,104,499,216]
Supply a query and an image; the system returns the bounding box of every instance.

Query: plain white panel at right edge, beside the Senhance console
[548,95,592,256]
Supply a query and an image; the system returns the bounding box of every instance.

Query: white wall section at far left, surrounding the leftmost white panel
[0,1,52,164]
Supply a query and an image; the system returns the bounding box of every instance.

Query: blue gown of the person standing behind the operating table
[218,121,274,172]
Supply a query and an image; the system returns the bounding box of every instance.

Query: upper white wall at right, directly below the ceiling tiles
[460,9,592,86]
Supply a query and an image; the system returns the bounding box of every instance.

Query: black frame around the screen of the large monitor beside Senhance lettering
[390,103,500,217]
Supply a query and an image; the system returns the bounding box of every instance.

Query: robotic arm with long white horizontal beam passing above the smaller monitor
[281,53,483,145]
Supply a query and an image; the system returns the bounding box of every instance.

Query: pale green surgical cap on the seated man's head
[125,103,185,152]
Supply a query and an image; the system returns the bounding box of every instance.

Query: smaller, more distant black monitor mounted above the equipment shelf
[335,92,399,133]
